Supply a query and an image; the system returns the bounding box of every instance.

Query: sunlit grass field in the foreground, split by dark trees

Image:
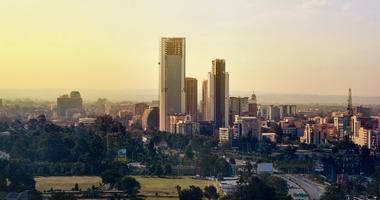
[35,176,218,200]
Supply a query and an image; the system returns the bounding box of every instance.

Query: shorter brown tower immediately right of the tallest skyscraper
[185,78,198,122]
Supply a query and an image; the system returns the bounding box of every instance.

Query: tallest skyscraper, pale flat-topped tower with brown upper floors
[159,38,186,131]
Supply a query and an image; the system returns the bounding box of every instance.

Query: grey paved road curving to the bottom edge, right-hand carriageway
[283,174,325,200]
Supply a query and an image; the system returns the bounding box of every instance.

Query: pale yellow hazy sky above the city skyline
[0,0,380,96]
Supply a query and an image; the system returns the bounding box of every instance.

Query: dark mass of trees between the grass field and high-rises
[0,115,231,176]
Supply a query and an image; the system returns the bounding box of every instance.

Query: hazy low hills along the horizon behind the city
[0,89,380,105]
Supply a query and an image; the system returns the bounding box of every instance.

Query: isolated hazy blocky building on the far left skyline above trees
[57,91,83,119]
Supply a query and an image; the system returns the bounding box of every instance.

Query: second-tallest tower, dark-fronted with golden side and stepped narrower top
[207,59,229,129]
